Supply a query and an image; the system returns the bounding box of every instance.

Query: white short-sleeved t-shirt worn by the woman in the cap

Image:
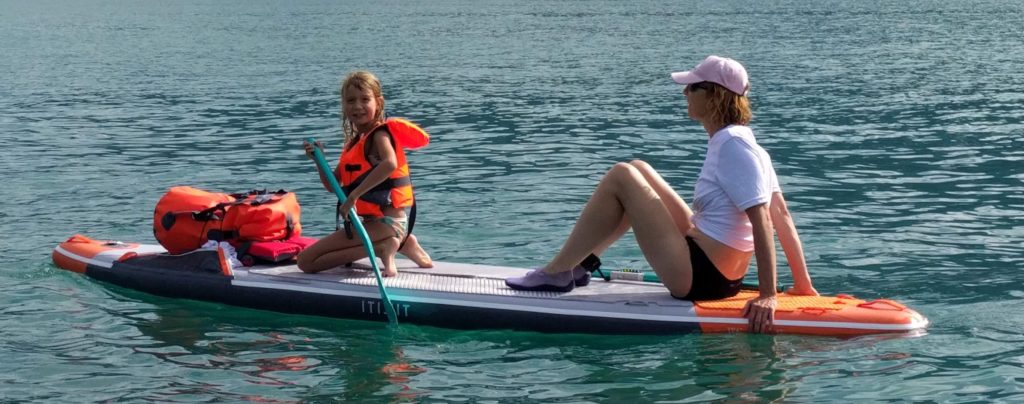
[692,125,781,252]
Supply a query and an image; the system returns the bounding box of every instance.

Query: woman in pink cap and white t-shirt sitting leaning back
[505,56,817,332]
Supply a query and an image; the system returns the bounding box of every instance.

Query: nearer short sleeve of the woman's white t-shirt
[718,138,778,211]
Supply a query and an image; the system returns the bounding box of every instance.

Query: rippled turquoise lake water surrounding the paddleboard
[0,0,1024,402]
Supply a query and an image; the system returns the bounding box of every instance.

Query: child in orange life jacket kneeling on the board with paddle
[298,72,433,276]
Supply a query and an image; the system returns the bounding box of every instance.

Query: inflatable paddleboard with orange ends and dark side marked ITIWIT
[52,235,928,335]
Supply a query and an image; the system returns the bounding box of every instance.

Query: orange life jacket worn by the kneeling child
[338,118,430,216]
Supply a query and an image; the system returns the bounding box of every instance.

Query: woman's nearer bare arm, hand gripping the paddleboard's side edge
[743,204,777,332]
